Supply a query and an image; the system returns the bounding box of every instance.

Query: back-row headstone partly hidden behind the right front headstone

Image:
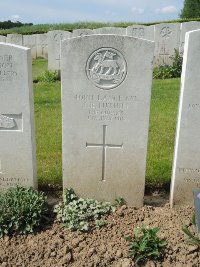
[179,21,200,54]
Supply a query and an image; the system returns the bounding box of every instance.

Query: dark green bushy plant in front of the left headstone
[0,186,47,237]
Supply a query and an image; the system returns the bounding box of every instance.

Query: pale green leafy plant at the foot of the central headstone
[54,188,115,231]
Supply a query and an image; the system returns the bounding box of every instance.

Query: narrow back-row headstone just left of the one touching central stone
[36,33,48,58]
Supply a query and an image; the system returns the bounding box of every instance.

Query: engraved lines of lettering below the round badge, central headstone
[74,94,136,121]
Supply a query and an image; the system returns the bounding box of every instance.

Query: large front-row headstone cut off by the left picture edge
[0,43,37,191]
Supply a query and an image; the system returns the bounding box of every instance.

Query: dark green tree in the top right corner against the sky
[180,0,200,19]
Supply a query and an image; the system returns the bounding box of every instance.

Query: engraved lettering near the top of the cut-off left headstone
[0,55,17,81]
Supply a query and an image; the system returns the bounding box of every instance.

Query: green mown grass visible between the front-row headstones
[33,59,180,185]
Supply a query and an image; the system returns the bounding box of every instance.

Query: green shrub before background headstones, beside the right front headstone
[153,49,183,79]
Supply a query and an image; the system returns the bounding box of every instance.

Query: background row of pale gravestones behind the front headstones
[0,21,200,67]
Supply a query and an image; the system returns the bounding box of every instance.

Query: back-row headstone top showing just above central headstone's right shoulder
[126,25,154,41]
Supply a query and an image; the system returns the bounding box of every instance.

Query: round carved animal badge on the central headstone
[86,48,127,90]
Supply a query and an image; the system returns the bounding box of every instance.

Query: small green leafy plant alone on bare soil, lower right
[125,224,167,264]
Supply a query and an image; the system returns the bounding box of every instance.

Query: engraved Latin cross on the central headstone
[86,125,123,181]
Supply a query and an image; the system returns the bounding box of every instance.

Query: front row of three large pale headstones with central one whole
[0,31,200,207]
